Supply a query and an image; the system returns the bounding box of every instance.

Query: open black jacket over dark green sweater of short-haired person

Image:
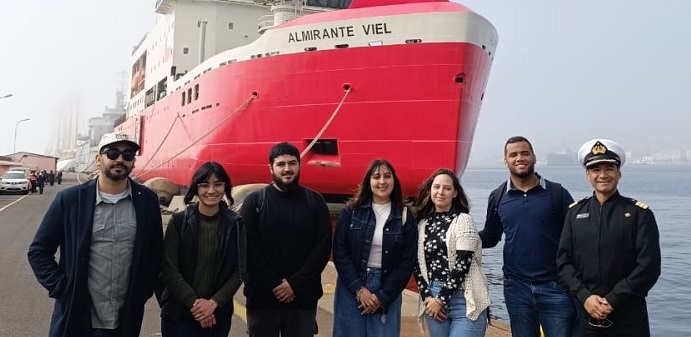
[160,204,247,322]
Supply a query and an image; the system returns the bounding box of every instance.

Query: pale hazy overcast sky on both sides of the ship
[0,0,691,165]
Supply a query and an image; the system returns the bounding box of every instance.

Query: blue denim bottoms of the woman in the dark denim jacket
[332,268,403,337]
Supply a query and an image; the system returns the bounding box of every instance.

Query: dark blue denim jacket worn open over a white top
[333,202,417,308]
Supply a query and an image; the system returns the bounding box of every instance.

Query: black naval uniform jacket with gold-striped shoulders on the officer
[557,192,661,312]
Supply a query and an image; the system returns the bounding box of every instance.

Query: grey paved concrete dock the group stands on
[0,173,511,337]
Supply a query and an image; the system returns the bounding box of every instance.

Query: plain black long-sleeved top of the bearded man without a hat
[240,185,331,310]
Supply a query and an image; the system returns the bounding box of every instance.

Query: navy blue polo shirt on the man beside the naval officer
[480,177,573,283]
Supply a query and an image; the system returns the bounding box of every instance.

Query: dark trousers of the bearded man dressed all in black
[247,308,317,337]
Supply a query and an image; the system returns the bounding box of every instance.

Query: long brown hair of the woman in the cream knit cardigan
[413,168,470,219]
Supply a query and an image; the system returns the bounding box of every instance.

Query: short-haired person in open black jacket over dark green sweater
[161,162,247,337]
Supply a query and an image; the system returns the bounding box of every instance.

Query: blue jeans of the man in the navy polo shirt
[504,278,580,337]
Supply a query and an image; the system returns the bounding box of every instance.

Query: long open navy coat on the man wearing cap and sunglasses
[28,179,163,337]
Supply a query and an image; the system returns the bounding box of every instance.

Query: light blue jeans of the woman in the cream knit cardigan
[425,281,487,337]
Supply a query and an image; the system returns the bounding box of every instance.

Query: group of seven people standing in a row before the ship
[29,133,660,337]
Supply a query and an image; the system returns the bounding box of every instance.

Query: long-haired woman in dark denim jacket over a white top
[333,159,417,337]
